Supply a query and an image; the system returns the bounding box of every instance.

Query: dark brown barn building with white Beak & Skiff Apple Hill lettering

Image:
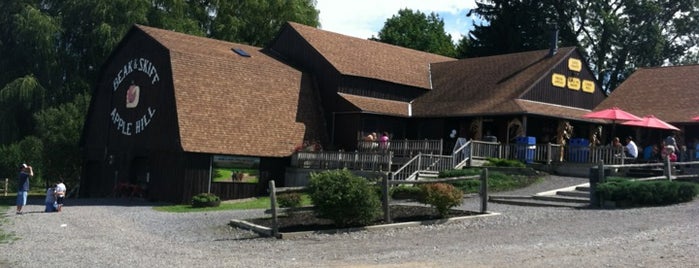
[81,23,605,202]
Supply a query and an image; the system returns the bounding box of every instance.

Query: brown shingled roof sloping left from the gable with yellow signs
[413,47,589,119]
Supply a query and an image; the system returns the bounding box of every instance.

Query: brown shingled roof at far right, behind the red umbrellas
[595,65,699,123]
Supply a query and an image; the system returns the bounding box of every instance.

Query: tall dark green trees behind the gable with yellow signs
[459,0,699,90]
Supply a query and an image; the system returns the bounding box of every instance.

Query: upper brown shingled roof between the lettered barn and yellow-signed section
[289,22,455,89]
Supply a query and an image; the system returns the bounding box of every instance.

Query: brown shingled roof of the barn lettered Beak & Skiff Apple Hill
[136,25,322,157]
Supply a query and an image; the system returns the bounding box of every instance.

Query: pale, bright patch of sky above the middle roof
[316,0,476,41]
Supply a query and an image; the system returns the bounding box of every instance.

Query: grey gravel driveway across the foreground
[0,176,699,268]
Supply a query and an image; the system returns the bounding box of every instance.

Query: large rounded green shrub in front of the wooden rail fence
[308,169,381,227]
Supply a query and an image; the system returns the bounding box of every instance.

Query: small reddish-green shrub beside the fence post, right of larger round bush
[420,183,464,218]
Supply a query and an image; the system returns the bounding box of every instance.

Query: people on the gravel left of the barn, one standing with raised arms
[17,163,66,215]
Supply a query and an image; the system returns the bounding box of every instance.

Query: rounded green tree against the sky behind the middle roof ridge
[370,8,456,57]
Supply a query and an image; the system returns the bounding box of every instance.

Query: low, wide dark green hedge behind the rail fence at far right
[597,179,699,206]
